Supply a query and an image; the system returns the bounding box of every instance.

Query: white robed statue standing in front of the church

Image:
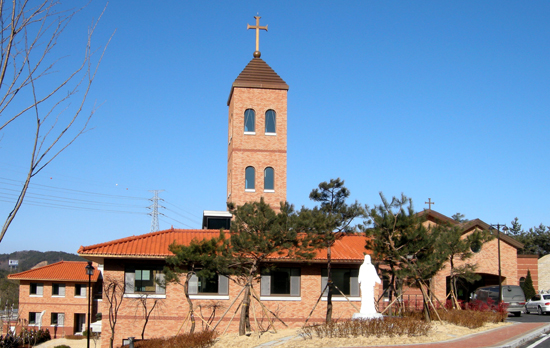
[353,255,382,319]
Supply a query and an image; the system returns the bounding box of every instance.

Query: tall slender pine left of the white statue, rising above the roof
[299,178,365,323]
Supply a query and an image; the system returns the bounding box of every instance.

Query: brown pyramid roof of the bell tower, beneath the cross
[227,58,288,105]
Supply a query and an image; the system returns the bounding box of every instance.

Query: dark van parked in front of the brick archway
[473,285,528,317]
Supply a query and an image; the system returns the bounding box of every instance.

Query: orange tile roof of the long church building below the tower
[78,228,367,262]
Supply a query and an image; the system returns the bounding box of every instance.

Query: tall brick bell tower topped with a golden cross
[227,16,288,210]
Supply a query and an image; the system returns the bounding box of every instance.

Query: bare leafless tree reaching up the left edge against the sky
[0,0,112,242]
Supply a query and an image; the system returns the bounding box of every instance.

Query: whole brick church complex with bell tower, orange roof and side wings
[5,17,536,348]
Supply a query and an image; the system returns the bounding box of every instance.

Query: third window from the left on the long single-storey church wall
[260,267,300,296]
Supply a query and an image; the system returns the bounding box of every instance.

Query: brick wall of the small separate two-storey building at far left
[12,280,98,338]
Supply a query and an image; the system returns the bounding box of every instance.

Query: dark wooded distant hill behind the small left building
[0,250,86,273]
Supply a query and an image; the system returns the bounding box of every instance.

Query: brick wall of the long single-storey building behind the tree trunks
[101,260,361,348]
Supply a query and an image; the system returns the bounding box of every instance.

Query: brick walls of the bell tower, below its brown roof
[227,88,287,209]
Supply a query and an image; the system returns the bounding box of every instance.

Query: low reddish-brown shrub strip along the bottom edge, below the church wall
[123,331,216,348]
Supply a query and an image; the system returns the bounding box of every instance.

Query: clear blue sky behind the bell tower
[0,1,550,253]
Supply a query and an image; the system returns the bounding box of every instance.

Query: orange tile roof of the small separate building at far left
[8,261,100,282]
